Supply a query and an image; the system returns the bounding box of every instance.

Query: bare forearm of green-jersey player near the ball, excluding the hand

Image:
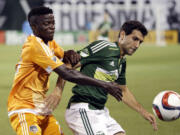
[122,86,146,115]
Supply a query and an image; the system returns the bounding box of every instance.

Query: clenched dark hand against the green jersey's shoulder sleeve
[63,50,81,66]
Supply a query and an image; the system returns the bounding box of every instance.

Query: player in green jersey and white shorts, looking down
[65,21,157,135]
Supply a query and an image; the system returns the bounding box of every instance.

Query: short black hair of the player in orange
[28,6,53,22]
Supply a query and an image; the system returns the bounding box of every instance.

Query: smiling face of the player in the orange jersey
[32,14,55,42]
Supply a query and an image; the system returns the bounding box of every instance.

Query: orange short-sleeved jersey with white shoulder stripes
[8,35,64,116]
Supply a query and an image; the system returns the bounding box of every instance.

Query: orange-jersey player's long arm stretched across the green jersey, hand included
[54,64,122,101]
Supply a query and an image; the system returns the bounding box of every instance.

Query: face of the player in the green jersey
[120,30,144,55]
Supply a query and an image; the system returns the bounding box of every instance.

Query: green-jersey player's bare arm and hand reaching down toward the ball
[120,85,158,131]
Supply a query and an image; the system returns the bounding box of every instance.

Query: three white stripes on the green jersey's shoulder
[91,41,117,53]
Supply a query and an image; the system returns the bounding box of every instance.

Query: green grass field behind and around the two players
[0,44,180,135]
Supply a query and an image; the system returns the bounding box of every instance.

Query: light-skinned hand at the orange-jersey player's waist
[44,90,61,112]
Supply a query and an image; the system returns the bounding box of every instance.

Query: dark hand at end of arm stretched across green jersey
[105,82,123,101]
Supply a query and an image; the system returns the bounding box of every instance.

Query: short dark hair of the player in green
[119,20,148,37]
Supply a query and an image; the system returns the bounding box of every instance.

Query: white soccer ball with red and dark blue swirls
[153,90,180,121]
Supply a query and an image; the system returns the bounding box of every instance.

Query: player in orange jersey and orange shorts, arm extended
[8,7,122,135]
